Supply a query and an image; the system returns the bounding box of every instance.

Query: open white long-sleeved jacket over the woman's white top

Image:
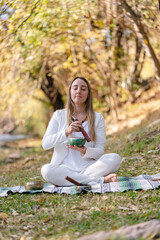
[42,109,106,166]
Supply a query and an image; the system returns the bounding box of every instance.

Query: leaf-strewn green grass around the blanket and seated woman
[0,121,160,240]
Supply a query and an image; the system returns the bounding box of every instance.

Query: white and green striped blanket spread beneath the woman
[0,173,160,197]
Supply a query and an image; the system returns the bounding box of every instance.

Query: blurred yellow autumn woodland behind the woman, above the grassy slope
[0,0,160,136]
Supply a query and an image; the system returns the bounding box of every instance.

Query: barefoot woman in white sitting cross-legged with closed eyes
[41,77,121,186]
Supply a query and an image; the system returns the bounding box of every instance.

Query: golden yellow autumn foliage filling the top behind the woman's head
[0,0,160,127]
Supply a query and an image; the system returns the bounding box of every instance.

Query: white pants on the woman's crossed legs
[41,153,121,186]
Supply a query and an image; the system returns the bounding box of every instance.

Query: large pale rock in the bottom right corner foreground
[78,219,160,240]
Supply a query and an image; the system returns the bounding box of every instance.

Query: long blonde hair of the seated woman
[66,77,96,141]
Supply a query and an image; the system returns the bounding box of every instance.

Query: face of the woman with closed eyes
[71,78,88,105]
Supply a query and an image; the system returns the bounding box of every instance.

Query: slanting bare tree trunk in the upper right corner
[120,0,160,79]
